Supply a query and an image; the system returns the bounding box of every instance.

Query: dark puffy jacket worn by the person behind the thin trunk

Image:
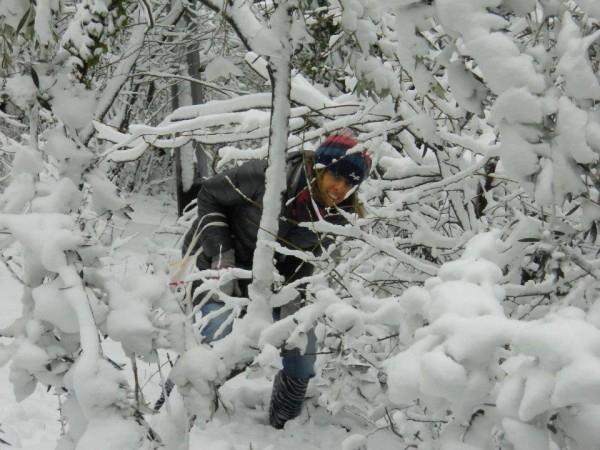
[183,155,353,281]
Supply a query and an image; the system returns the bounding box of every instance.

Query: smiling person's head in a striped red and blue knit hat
[314,129,371,206]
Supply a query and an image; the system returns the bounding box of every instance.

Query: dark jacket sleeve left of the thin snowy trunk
[184,161,266,260]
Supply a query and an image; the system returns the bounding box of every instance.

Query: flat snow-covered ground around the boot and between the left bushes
[0,195,400,450]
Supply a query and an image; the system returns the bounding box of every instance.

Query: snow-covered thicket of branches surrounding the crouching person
[0,0,600,449]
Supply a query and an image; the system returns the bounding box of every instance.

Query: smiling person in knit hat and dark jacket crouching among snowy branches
[157,129,371,428]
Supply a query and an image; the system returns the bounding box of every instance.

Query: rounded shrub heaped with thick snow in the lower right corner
[385,232,600,449]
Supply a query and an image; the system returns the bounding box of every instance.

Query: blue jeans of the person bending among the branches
[200,301,317,380]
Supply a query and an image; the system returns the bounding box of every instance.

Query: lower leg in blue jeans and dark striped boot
[269,330,317,429]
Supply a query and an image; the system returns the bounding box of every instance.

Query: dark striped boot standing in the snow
[269,372,308,429]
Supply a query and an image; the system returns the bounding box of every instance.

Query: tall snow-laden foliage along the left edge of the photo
[0,1,191,449]
